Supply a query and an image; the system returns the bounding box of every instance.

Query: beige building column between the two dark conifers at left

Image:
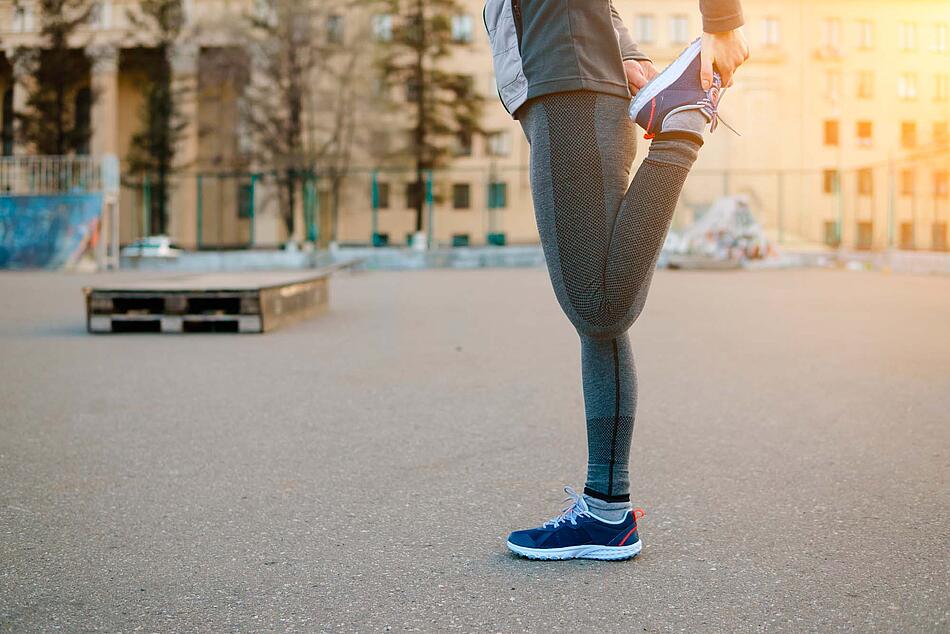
[86,45,119,157]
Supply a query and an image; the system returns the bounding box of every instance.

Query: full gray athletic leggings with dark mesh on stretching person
[518,92,699,502]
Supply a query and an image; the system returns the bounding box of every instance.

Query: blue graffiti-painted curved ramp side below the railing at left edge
[0,194,102,269]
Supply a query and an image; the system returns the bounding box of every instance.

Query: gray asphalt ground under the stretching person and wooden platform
[0,270,950,632]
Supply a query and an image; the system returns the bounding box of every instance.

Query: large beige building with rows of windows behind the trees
[0,0,950,250]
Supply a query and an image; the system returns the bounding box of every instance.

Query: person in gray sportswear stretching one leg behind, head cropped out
[484,0,748,559]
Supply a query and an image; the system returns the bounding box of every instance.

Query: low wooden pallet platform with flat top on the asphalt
[83,270,330,333]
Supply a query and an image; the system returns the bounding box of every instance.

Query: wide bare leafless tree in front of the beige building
[241,0,368,242]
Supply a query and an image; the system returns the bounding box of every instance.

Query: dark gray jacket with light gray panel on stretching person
[484,0,743,117]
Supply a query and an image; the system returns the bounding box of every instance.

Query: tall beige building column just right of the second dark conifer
[168,43,201,248]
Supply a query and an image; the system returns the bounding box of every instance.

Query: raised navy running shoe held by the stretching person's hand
[630,38,735,139]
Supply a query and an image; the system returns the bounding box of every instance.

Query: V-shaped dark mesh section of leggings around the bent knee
[542,92,688,327]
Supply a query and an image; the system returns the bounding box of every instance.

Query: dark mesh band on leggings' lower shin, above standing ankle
[587,416,633,495]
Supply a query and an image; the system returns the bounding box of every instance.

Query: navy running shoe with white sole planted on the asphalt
[508,487,643,559]
